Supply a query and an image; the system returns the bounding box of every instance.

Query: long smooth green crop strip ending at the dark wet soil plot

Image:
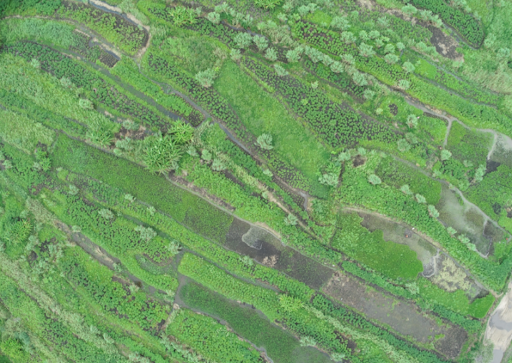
[52,135,233,243]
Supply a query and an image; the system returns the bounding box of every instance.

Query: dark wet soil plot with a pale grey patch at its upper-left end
[225,218,333,290]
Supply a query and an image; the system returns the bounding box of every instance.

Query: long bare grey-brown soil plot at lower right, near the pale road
[323,273,468,359]
